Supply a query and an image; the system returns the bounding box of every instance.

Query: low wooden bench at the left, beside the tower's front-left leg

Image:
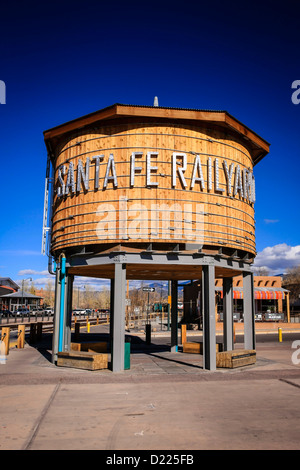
[57,350,108,370]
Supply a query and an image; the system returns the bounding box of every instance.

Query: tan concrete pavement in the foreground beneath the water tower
[0,330,300,452]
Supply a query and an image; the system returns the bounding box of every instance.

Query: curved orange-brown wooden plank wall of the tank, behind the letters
[51,119,255,255]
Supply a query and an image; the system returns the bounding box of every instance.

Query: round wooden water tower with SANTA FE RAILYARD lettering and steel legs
[44,103,269,370]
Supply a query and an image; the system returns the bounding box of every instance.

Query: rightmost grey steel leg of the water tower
[243,272,255,349]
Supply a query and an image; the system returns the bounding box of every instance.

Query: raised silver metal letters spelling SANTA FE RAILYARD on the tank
[56,151,255,203]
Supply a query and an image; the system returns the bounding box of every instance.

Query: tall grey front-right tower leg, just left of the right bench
[202,265,216,370]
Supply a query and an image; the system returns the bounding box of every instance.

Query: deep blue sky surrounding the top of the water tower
[0,0,300,287]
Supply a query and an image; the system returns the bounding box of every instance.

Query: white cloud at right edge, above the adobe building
[254,243,300,275]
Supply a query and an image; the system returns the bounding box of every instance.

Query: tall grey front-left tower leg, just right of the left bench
[111,263,126,372]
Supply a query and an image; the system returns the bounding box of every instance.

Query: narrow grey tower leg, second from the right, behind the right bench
[223,277,234,351]
